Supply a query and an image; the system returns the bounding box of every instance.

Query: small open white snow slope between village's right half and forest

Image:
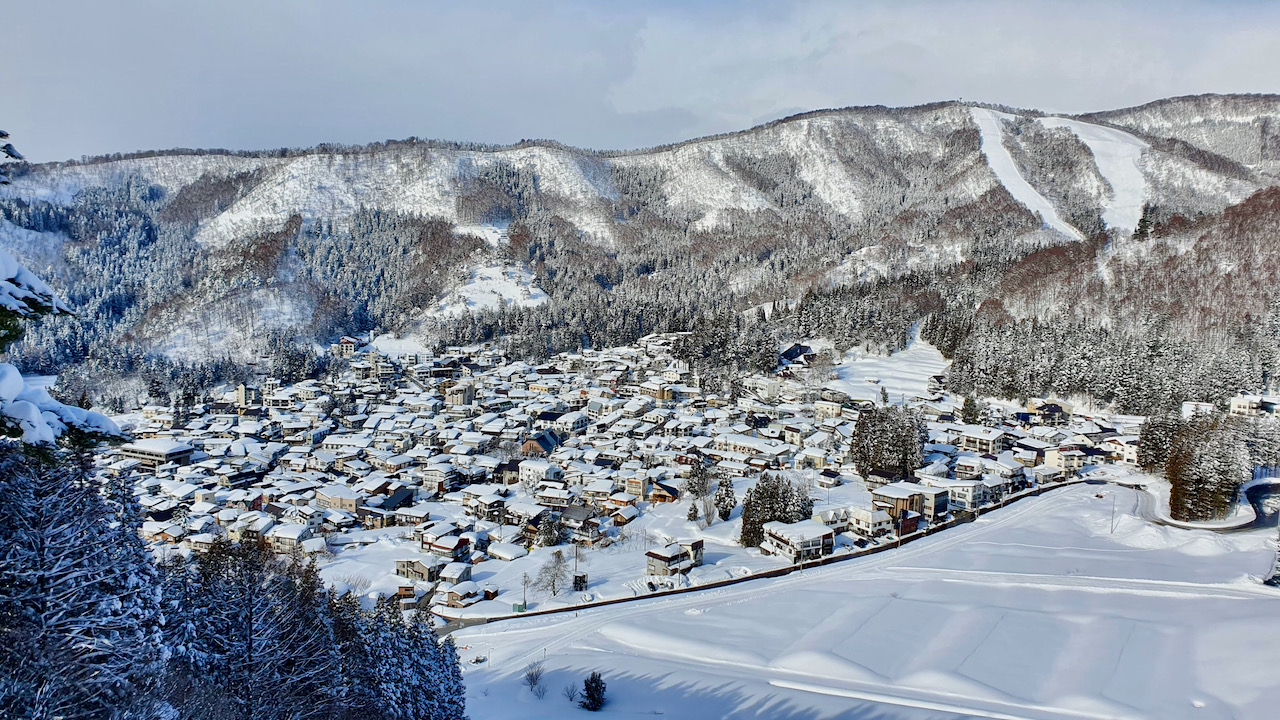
[826,332,951,405]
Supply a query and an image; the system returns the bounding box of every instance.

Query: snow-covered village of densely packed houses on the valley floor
[96,333,1280,623]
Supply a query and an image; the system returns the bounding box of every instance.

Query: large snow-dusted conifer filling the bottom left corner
[0,442,161,720]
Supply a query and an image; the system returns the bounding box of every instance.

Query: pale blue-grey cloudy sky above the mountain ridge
[10,0,1280,161]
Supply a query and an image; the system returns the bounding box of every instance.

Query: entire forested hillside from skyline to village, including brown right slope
[0,96,1280,410]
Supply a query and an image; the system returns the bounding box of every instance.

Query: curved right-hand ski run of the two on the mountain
[1039,118,1148,233]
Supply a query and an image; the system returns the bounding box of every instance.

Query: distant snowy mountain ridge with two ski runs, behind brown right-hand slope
[0,96,1280,397]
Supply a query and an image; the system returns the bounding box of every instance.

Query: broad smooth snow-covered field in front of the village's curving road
[454,486,1280,720]
